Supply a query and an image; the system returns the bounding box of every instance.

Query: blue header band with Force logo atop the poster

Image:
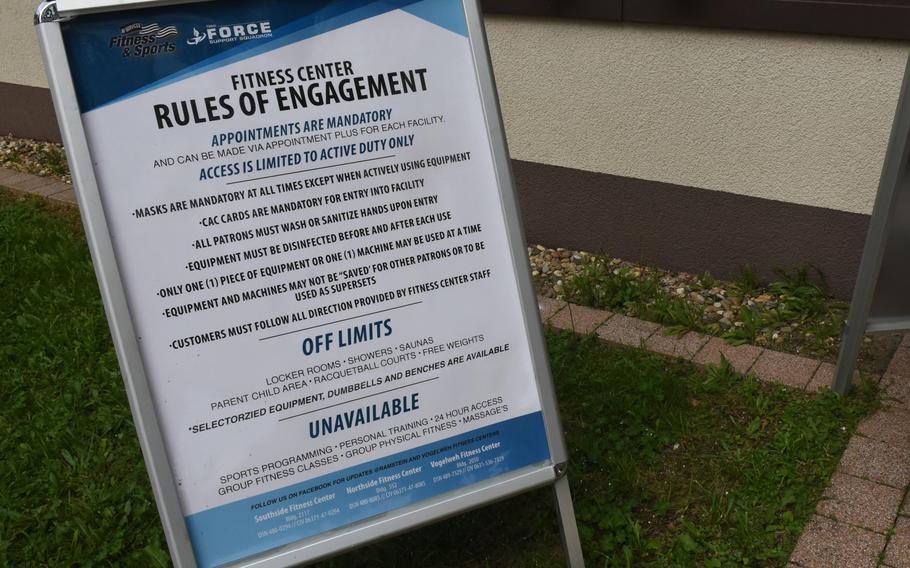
[61,0,467,112]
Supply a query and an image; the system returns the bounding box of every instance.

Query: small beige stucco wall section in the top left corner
[0,0,47,87]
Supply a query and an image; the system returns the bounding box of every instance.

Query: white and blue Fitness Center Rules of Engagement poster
[64,0,550,566]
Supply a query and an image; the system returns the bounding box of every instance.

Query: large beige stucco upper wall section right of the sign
[487,17,908,215]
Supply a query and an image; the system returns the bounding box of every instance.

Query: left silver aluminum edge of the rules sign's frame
[35,0,196,568]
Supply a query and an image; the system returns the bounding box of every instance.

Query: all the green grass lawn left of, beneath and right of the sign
[0,196,876,568]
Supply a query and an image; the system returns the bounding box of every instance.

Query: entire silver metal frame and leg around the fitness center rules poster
[35,0,584,568]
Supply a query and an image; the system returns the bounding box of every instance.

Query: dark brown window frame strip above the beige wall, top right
[482,0,910,40]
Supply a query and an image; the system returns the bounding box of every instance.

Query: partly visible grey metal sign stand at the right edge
[831,58,910,394]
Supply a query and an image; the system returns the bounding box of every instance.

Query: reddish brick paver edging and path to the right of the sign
[538,298,910,568]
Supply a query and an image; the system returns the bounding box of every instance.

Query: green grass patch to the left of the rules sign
[0,194,168,566]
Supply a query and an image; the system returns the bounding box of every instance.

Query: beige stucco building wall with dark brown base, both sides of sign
[0,6,910,296]
